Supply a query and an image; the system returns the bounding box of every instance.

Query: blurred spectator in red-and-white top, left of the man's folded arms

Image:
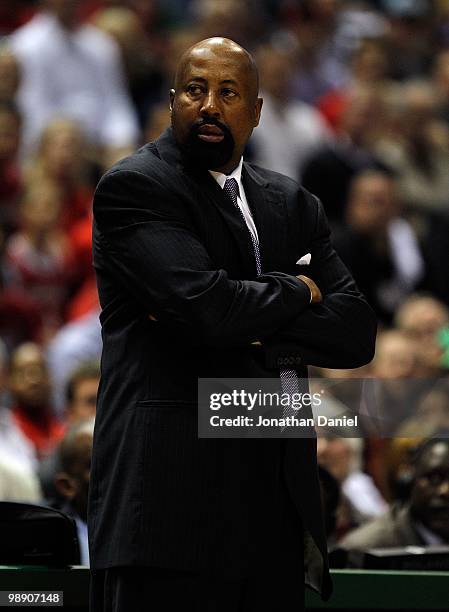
[4,183,71,341]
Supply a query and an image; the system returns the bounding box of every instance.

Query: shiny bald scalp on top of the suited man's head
[174,37,259,99]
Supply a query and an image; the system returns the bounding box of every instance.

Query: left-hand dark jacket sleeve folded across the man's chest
[94,170,310,346]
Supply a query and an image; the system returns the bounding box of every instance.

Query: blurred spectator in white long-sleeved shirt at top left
[11,0,137,162]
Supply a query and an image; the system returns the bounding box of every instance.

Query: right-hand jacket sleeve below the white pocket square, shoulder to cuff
[265,193,377,368]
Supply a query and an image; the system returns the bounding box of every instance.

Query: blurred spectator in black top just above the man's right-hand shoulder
[302,88,385,223]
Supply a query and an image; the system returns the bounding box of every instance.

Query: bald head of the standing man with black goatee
[170,38,262,174]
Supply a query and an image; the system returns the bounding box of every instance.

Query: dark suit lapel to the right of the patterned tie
[242,163,287,272]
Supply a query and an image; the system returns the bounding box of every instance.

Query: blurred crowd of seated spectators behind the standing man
[0,0,449,563]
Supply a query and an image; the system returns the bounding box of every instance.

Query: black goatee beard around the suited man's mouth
[174,117,235,170]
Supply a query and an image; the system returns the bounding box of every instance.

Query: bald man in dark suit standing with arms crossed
[89,38,375,612]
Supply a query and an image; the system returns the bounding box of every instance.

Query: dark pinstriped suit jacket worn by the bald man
[89,130,376,595]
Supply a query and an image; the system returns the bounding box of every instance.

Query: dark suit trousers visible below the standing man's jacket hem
[90,567,304,612]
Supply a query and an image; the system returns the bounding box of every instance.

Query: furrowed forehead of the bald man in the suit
[180,48,250,85]
